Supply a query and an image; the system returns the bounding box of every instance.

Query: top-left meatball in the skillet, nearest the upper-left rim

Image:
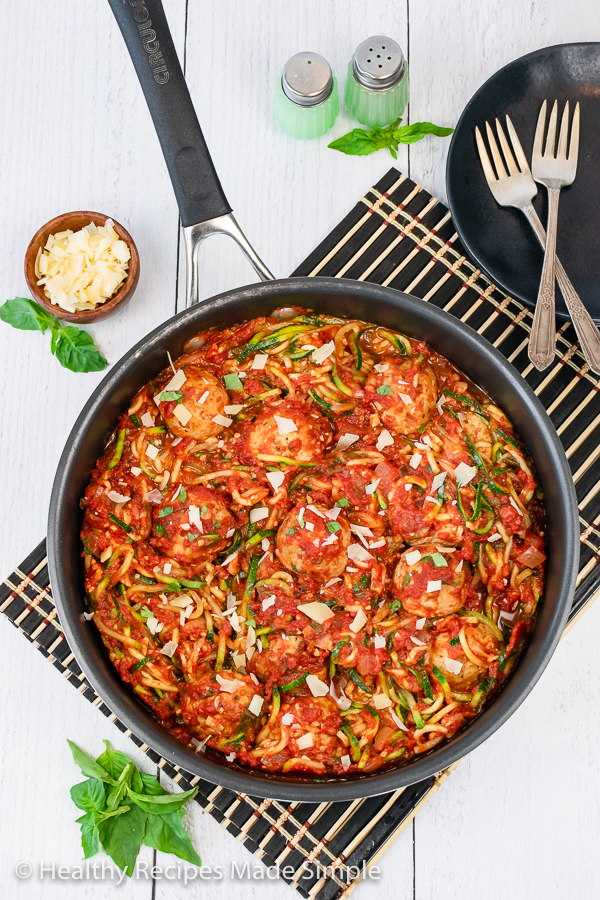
[158,366,229,441]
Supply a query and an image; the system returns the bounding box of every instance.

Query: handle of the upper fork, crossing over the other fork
[529,187,560,371]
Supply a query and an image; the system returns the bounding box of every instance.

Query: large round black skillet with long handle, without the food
[48,0,579,802]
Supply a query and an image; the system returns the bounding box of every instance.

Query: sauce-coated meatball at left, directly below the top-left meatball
[150,484,235,563]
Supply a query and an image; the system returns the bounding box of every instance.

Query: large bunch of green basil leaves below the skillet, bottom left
[69,741,202,876]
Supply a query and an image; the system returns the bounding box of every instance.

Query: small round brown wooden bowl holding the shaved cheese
[25,212,140,322]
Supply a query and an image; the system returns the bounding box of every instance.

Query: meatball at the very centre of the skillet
[276,504,350,581]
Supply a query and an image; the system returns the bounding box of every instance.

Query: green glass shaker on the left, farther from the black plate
[275,51,339,140]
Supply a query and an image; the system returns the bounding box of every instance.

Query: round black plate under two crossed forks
[446,43,600,322]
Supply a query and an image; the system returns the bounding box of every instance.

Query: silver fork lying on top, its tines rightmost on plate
[529,100,579,369]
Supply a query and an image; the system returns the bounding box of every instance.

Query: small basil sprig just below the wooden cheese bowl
[0,297,108,372]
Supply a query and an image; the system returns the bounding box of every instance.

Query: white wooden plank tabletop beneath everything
[0,0,600,900]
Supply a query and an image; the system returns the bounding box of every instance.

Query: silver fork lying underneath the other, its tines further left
[475,116,600,374]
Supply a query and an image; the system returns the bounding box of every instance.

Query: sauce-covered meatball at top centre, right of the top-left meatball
[240,400,331,463]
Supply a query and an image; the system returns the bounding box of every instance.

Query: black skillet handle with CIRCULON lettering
[108,0,231,227]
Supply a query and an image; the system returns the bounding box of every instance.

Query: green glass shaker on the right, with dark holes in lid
[345,34,408,126]
